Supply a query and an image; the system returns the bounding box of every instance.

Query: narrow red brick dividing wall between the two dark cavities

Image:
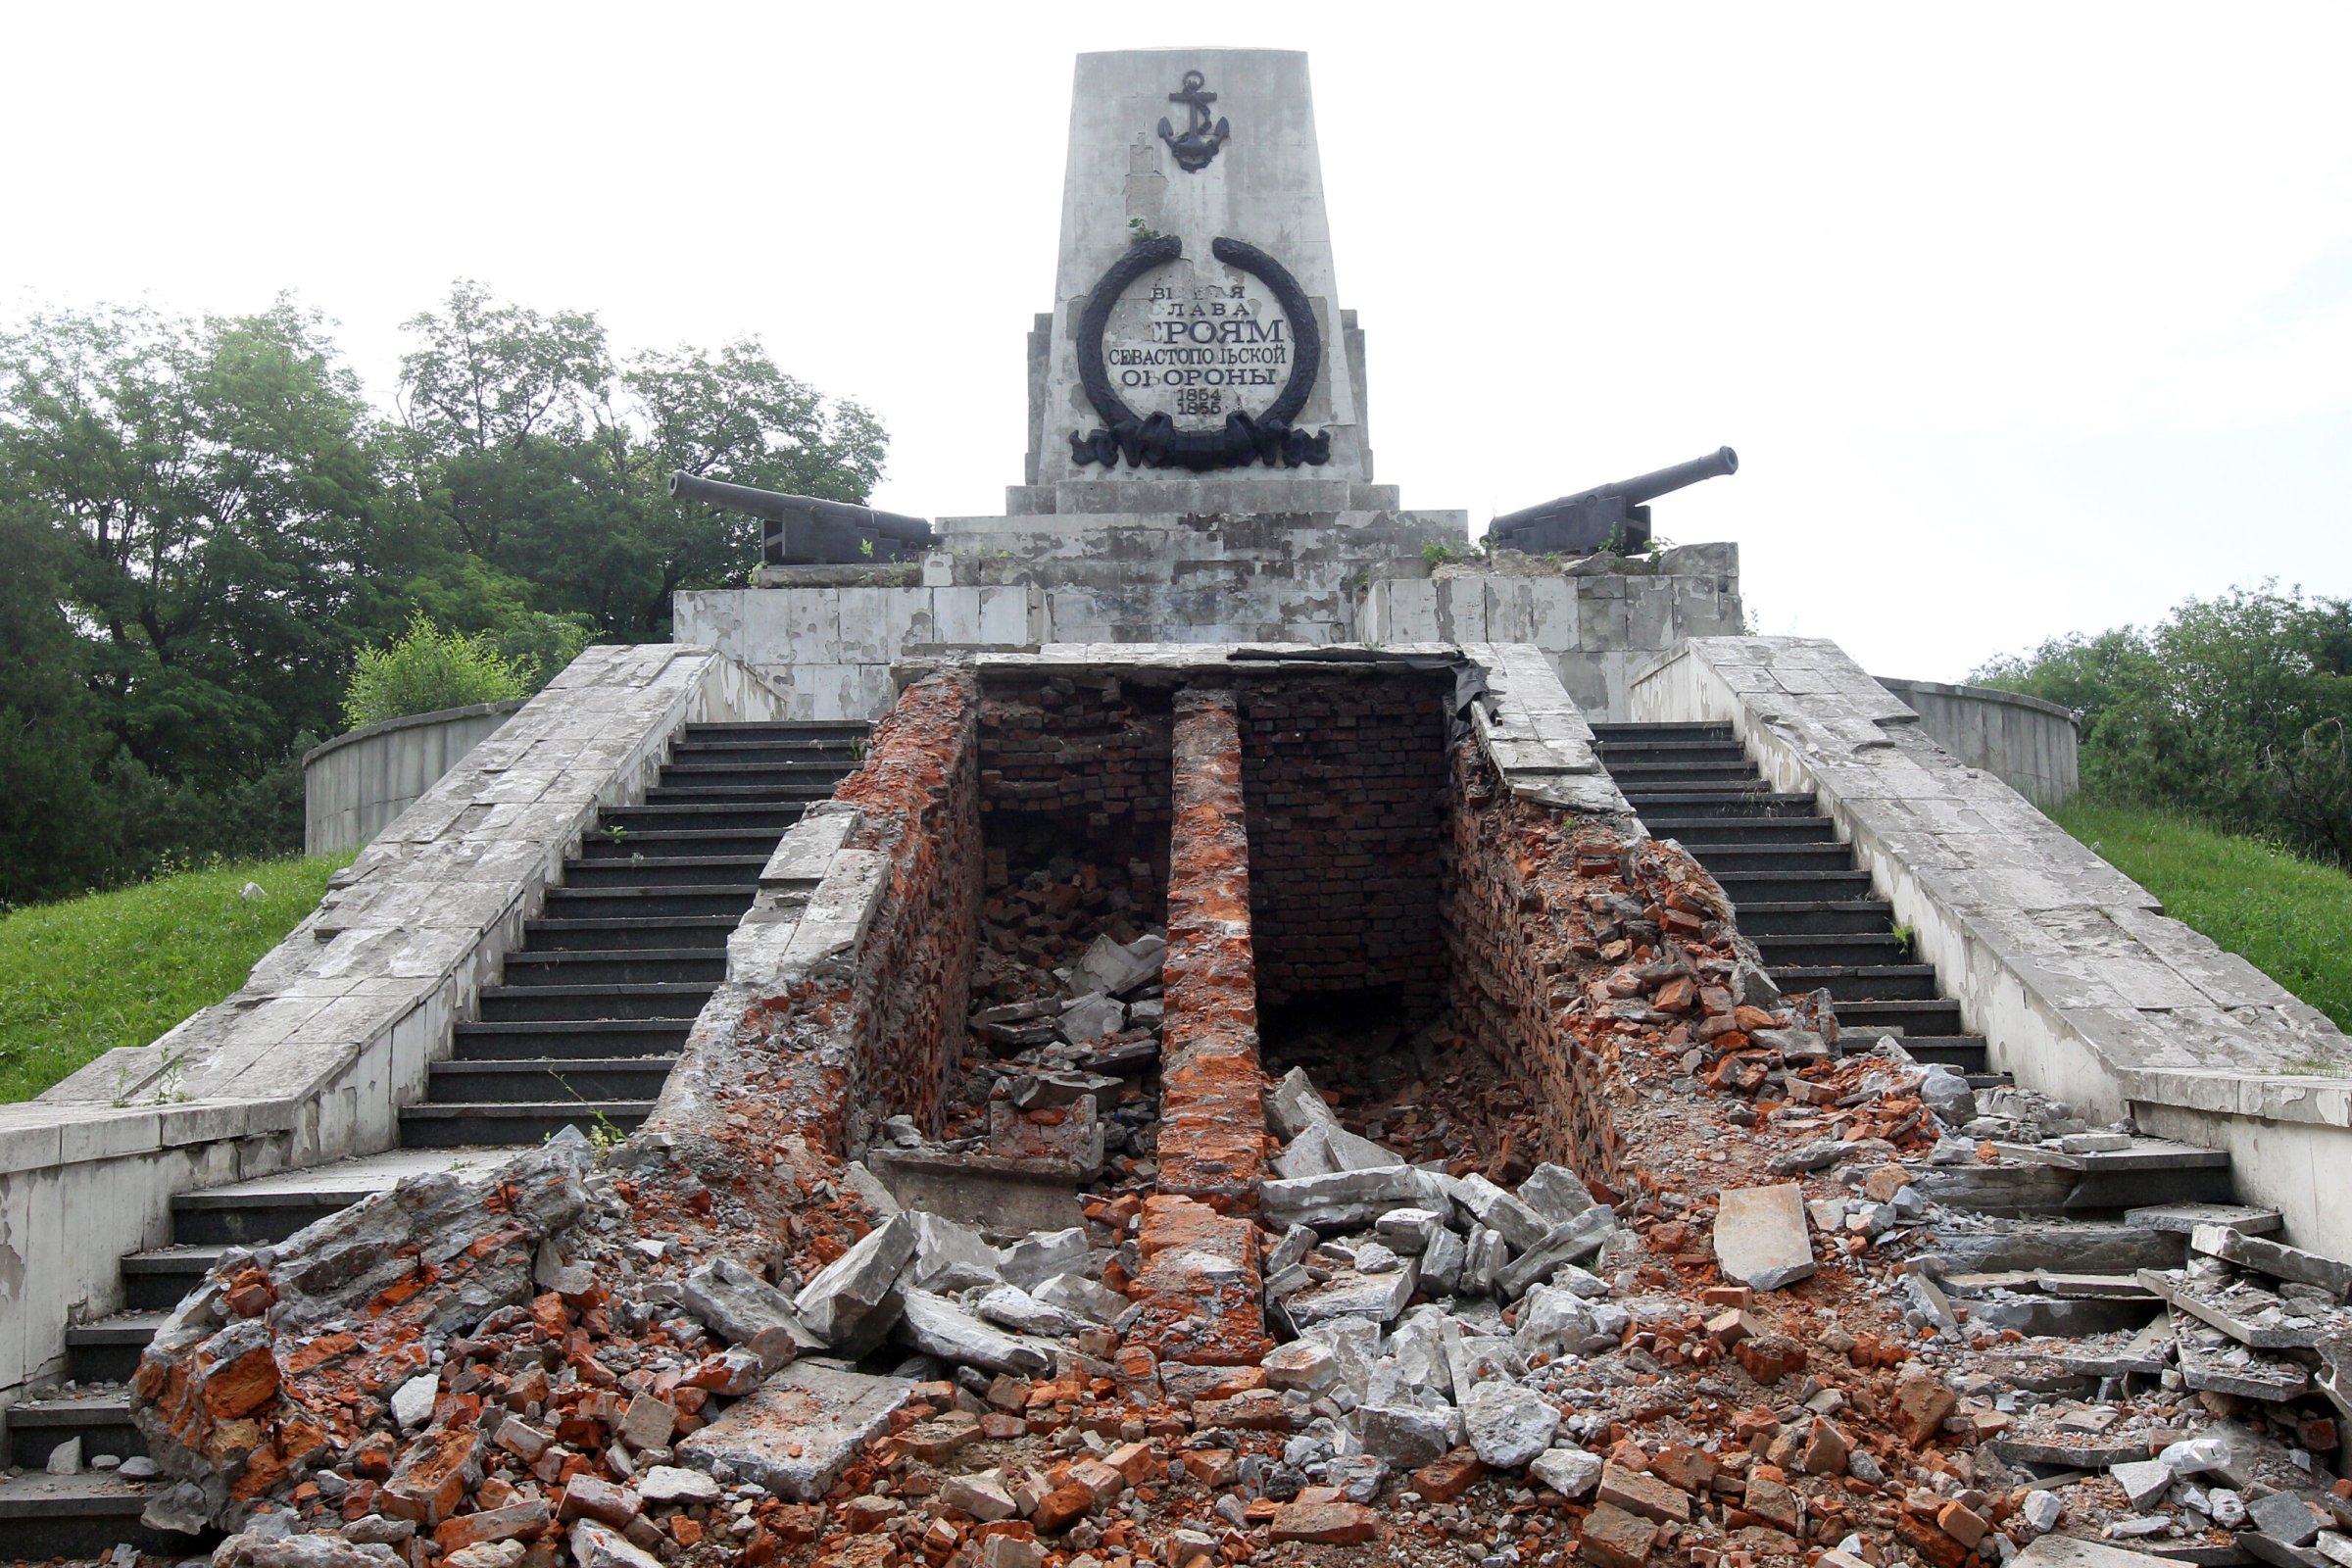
[1159,691,1265,1213]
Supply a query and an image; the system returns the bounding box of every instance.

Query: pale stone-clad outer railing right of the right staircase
[1633,637,2352,1257]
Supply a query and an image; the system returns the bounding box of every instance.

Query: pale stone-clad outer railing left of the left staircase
[0,644,781,1403]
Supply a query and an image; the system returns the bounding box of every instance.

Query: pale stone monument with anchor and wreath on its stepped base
[677,49,1739,719]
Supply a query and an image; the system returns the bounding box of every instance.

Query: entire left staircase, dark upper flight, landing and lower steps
[0,724,868,1561]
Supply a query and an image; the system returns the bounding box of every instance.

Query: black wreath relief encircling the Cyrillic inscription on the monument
[1070,235,1331,472]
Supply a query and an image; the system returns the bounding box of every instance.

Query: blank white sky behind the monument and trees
[0,0,2352,679]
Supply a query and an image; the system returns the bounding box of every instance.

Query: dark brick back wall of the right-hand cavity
[1242,672,1453,1010]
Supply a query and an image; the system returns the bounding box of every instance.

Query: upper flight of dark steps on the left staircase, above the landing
[400,724,865,1150]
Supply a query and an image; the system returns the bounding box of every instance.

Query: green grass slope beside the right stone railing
[2051,802,2352,1030]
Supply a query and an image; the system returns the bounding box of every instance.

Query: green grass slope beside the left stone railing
[0,856,351,1102]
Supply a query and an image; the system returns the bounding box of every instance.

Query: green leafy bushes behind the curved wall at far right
[1974,583,2352,865]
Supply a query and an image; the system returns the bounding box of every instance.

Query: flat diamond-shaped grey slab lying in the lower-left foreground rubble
[677,1361,915,1502]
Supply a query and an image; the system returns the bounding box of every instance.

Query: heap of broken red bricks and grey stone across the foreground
[115,738,2352,1568]
